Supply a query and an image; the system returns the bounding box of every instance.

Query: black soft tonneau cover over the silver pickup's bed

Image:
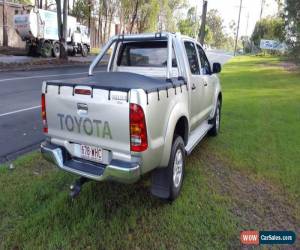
[47,72,186,93]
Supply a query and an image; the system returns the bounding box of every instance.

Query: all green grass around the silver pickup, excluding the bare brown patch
[0,57,300,249]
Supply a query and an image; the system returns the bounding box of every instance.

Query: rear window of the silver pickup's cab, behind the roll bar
[117,41,177,67]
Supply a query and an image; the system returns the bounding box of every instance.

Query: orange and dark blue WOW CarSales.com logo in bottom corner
[240,231,296,245]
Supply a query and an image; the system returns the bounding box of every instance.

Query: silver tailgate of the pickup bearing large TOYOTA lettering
[44,84,130,154]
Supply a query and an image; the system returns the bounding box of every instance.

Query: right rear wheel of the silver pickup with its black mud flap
[151,136,185,201]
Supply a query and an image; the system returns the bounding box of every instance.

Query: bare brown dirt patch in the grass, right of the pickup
[193,146,300,249]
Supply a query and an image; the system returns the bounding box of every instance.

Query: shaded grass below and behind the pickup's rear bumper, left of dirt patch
[0,153,237,249]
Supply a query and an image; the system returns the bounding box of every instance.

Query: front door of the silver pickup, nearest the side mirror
[197,44,216,119]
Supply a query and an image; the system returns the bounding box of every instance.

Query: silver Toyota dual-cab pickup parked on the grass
[41,33,222,200]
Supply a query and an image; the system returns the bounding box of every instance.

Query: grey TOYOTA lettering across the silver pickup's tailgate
[57,113,112,139]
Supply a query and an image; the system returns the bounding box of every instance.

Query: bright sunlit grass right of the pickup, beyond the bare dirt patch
[210,57,300,200]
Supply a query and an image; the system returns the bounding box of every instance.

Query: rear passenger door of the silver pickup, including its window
[184,41,205,130]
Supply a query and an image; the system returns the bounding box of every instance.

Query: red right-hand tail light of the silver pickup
[129,103,148,152]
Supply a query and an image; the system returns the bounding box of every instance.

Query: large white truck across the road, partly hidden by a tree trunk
[14,8,90,58]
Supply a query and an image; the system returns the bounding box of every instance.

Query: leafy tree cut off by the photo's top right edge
[285,0,300,61]
